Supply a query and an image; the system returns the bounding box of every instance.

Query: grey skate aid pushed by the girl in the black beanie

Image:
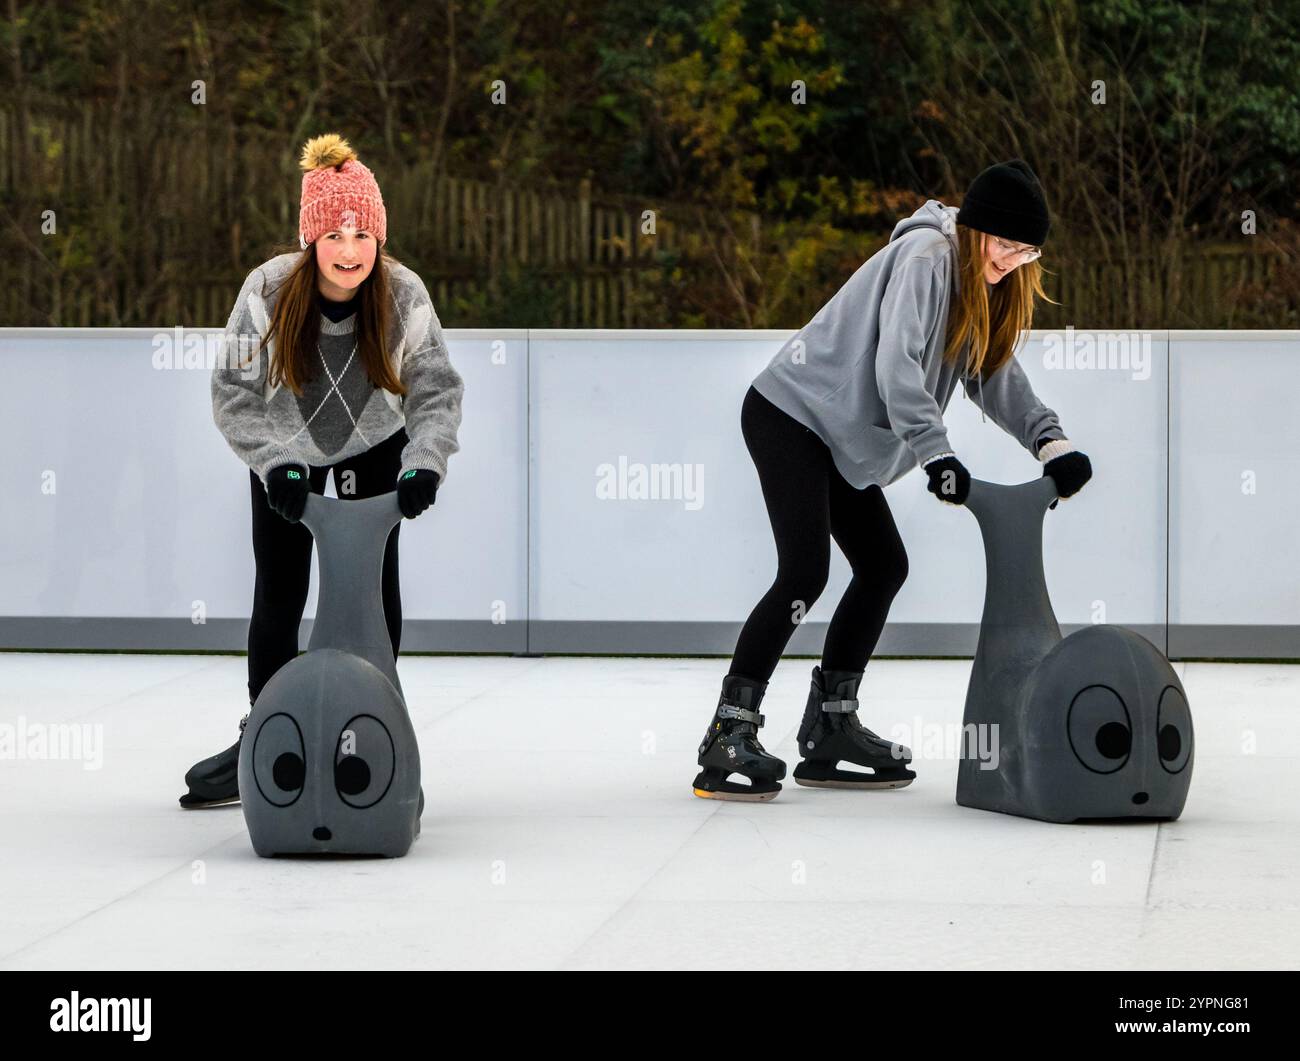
[957,476,1193,822]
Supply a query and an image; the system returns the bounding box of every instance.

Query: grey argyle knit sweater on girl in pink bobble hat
[212,252,464,485]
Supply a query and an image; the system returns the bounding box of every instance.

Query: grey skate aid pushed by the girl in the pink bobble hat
[239,491,423,858]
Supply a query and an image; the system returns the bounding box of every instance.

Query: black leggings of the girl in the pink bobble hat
[248,428,408,703]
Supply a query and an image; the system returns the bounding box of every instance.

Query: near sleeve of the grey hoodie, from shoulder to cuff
[876,257,950,464]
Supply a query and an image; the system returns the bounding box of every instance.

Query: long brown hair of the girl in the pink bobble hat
[257,243,407,397]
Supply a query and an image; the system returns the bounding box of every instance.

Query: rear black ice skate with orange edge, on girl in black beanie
[694,675,785,802]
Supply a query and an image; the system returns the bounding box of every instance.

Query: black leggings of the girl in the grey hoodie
[731,387,907,681]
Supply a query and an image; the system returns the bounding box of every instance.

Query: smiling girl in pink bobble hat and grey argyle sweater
[181,133,464,807]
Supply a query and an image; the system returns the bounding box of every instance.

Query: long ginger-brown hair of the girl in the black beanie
[944,225,1060,380]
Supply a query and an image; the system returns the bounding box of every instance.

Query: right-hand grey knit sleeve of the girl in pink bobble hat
[399,281,465,484]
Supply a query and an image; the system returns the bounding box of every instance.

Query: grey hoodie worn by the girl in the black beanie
[754,199,1065,489]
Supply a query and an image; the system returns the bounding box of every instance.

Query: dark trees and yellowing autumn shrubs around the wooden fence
[0,0,1300,326]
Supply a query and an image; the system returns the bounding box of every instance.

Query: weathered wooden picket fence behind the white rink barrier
[0,104,1294,328]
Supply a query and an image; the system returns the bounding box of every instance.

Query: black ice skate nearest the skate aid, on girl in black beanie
[794,667,917,788]
